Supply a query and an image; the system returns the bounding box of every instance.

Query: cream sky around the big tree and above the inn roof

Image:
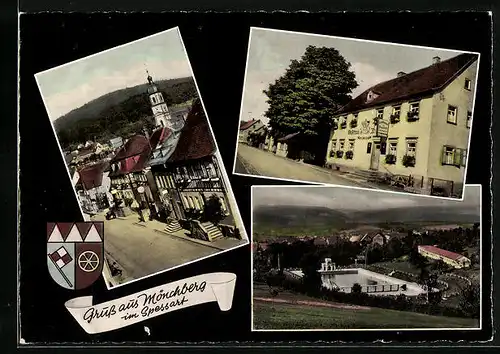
[240,28,472,123]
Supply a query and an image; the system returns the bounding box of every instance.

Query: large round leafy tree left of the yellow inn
[264,46,358,164]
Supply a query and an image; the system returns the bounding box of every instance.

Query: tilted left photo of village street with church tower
[35,28,249,288]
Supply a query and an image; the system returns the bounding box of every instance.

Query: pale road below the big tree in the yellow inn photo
[235,144,376,188]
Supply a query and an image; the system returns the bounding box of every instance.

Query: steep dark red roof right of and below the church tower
[168,100,215,162]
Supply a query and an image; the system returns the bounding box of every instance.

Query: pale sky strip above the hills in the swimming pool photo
[253,185,481,211]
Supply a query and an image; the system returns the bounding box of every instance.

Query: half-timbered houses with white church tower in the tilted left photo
[75,74,239,241]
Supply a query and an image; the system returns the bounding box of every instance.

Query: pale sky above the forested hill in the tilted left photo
[35,28,192,121]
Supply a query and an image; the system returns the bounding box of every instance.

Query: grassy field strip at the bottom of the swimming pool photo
[253,284,479,330]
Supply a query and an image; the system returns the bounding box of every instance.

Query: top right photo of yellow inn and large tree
[237,28,479,199]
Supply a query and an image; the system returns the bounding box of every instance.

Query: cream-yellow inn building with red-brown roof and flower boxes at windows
[326,54,478,196]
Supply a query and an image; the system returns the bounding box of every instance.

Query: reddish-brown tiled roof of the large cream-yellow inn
[339,54,478,113]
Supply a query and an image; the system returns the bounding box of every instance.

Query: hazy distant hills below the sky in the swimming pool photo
[253,205,479,238]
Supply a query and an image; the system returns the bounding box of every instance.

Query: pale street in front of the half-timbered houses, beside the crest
[94,216,224,281]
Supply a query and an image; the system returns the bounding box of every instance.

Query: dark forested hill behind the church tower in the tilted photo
[54,77,197,148]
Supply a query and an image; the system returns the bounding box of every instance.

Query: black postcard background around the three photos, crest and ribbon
[19,13,491,344]
